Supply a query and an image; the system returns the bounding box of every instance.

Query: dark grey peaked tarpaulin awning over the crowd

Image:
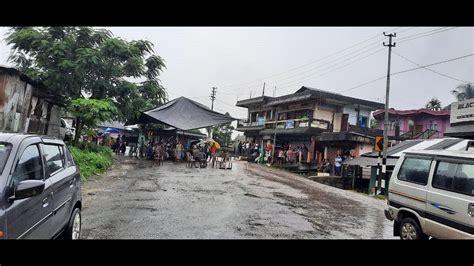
[138,97,237,130]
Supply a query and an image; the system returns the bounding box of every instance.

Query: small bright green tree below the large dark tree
[68,98,118,143]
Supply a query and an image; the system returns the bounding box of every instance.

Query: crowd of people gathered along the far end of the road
[109,135,353,176]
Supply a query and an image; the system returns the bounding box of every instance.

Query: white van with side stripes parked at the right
[385,150,474,240]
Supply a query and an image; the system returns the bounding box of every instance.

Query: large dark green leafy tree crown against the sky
[6,27,167,122]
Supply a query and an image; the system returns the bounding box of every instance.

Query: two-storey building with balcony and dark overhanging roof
[236,86,384,164]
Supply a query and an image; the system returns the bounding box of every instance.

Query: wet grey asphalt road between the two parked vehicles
[81,159,394,239]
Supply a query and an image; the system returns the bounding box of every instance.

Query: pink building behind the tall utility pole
[373,108,450,140]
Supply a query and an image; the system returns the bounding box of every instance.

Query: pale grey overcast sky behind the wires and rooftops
[0,27,474,122]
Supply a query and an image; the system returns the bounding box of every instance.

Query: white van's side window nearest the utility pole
[398,157,431,185]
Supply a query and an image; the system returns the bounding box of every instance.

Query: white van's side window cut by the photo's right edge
[432,162,474,196]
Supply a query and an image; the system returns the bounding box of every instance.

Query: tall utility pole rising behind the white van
[382,32,397,194]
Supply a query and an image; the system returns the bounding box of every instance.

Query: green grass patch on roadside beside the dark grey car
[68,143,113,180]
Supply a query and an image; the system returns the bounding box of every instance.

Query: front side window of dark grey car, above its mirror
[12,145,44,186]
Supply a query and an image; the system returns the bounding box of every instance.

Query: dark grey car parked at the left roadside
[0,133,82,239]
